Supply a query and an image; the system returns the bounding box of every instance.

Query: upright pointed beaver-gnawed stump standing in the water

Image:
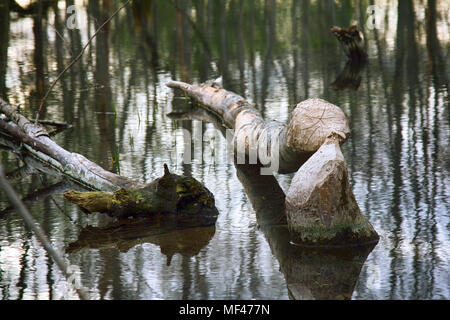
[286,136,379,245]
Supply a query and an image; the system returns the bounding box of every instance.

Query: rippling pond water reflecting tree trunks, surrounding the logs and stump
[0,0,450,299]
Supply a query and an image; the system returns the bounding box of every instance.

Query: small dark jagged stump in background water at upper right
[330,25,367,61]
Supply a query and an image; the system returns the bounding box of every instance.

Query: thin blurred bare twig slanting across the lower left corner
[0,164,89,300]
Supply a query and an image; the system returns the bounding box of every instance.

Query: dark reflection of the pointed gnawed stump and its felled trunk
[237,165,375,300]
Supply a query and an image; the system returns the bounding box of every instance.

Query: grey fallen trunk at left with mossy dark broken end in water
[0,99,218,218]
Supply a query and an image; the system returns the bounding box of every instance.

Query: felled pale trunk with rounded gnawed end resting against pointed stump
[167,81,350,173]
